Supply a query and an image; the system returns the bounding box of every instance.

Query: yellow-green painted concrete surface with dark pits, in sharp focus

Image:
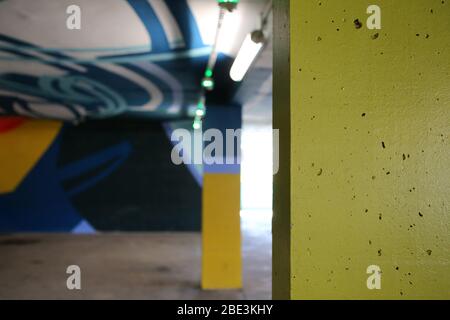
[274,0,450,299]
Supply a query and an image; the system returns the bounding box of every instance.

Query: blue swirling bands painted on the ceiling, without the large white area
[0,0,210,122]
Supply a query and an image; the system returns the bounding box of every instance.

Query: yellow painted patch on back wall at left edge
[0,120,62,194]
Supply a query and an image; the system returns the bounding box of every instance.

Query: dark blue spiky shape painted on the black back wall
[0,138,132,232]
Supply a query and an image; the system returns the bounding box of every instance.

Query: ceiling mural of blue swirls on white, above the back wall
[0,0,229,122]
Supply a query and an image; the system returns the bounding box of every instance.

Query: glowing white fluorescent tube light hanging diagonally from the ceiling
[230,31,264,82]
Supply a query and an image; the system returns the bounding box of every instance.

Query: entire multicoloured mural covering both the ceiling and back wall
[0,0,256,232]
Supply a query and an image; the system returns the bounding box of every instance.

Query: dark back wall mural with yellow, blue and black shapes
[0,118,201,233]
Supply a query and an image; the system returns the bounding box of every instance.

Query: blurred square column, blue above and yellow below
[202,107,242,289]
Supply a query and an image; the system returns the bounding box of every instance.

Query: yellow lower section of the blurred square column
[202,174,242,289]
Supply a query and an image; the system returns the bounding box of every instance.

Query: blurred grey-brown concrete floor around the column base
[0,215,271,300]
